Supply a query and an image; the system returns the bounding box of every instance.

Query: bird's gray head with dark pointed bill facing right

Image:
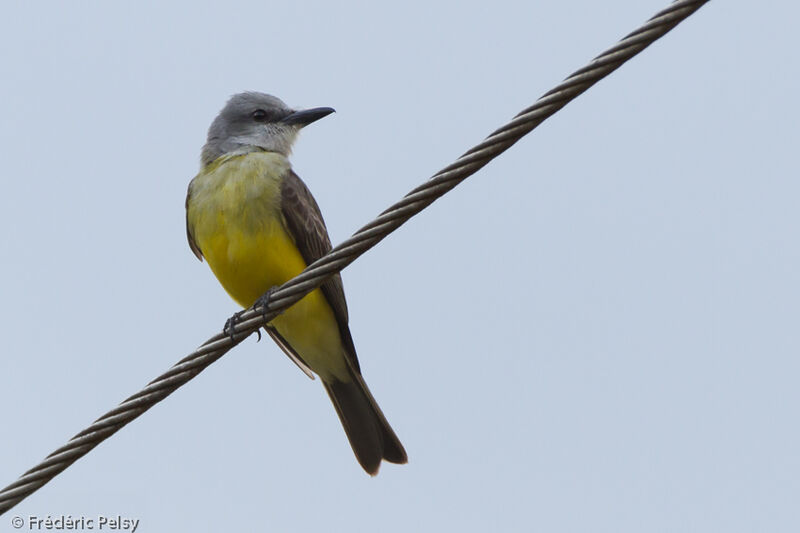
[201,92,333,166]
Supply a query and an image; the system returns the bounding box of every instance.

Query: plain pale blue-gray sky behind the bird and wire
[0,0,800,533]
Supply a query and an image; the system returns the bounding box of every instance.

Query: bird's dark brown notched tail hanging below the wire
[322,371,408,476]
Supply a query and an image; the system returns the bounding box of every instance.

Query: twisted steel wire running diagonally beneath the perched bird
[0,0,708,514]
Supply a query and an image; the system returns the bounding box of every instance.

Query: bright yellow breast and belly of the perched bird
[188,152,349,379]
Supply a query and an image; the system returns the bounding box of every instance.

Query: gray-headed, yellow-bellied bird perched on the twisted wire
[186,91,408,476]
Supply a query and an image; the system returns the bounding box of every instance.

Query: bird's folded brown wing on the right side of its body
[281,170,360,372]
